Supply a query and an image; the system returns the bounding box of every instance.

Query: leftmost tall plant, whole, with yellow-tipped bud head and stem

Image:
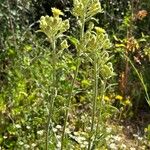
[40,8,70,150]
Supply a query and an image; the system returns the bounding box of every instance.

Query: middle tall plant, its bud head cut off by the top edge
[61,0,102,150]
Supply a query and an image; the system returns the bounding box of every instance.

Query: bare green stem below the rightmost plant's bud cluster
[88,56,98,150]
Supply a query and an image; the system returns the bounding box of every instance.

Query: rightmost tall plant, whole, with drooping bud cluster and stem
[79,23,114,150]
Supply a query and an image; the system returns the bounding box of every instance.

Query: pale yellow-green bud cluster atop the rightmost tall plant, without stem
[77,24,114,79]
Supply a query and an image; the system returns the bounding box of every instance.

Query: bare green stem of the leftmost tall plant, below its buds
[46,40,57,150]
